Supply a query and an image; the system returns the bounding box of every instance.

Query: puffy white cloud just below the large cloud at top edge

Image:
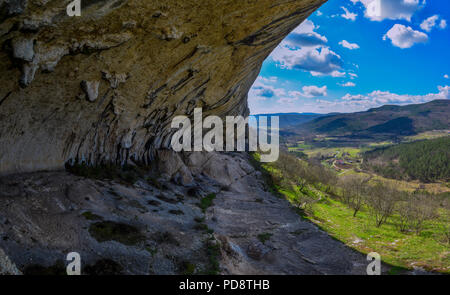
[383,24,428,49]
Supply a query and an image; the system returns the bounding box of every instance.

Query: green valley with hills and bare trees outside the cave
[255,102,450,274]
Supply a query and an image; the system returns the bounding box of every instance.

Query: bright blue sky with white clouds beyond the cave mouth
[249,0,450,114]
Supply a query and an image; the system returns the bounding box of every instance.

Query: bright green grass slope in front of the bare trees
[307,198,450,273]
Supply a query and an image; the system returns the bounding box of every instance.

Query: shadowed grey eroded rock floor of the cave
[0,152,386,274]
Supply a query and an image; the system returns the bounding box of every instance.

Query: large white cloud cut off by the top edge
[351,0,426,21]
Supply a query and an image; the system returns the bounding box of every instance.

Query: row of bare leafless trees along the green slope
[271,153,450,239]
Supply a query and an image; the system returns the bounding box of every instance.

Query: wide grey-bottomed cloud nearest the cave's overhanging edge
[270,43,343,76]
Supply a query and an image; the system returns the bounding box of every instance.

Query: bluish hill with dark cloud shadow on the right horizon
[285,100,450,137]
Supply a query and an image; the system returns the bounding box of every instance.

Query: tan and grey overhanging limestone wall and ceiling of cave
[0,0,325,174]
